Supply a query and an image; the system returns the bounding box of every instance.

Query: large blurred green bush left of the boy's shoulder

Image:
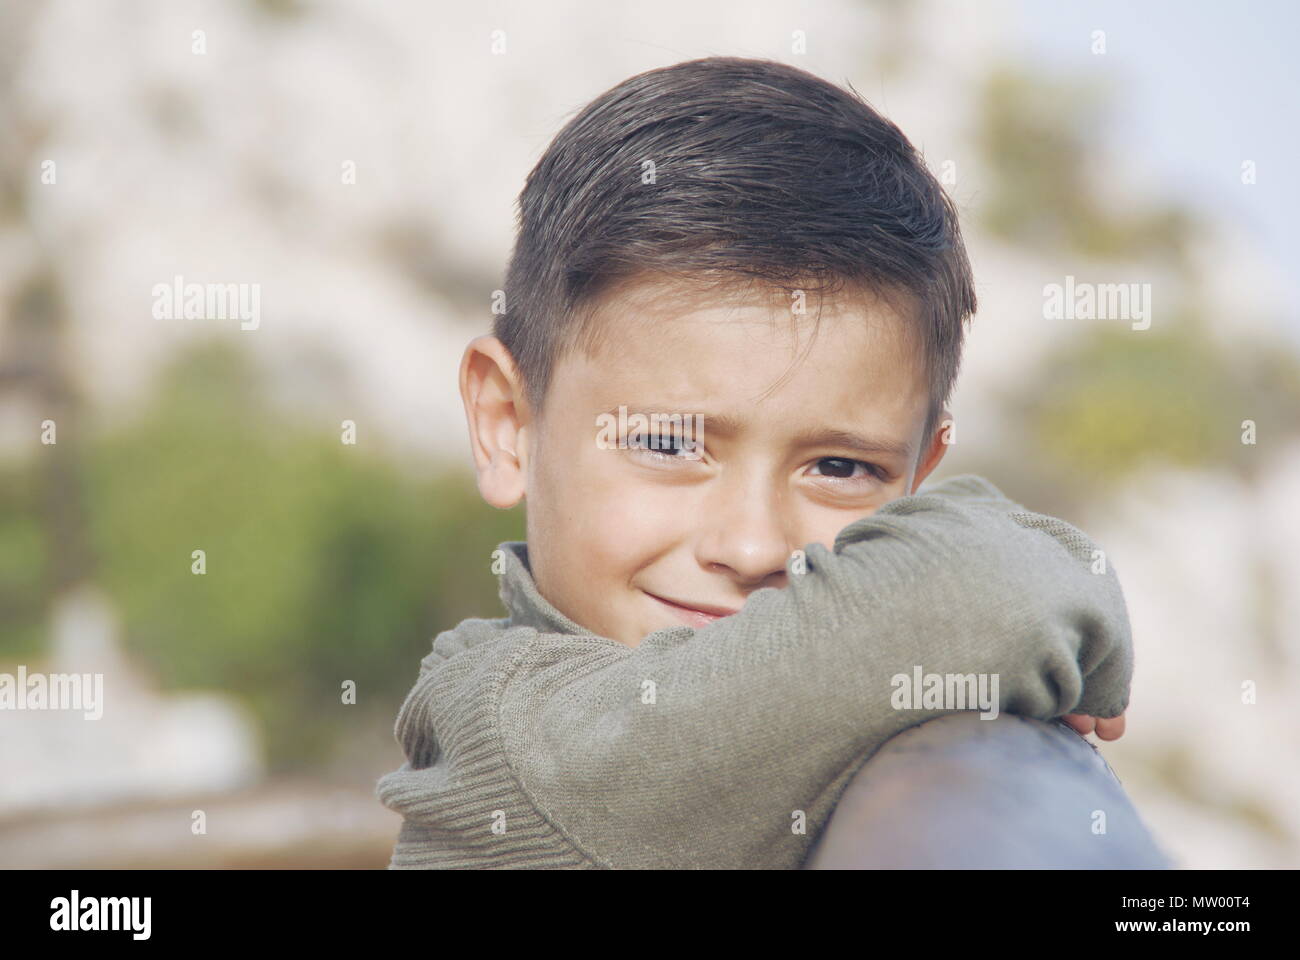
[0,345,524,770]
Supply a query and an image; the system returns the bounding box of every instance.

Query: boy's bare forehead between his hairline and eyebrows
[553,269,928,421]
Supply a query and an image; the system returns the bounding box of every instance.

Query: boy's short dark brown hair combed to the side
[493,57,976,436]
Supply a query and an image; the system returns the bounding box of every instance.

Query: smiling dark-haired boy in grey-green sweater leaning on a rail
[377,57,1132,868]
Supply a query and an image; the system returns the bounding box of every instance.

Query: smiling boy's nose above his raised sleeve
[696,467,796,589]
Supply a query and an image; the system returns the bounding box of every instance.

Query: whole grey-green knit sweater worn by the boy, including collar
[376,476,1132,869]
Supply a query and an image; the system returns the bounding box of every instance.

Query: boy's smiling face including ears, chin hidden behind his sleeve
[462,282,946,647]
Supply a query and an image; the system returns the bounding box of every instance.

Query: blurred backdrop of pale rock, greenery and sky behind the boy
[0,0,1300,868]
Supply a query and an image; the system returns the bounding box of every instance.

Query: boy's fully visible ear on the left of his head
[460,336,532,510]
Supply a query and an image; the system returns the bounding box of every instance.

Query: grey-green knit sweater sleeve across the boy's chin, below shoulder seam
[499,476,1132,868]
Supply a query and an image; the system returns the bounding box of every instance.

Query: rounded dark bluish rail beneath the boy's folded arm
[805,712,1177,870]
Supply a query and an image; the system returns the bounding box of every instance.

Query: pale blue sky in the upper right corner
[1014,0,1300,341]
